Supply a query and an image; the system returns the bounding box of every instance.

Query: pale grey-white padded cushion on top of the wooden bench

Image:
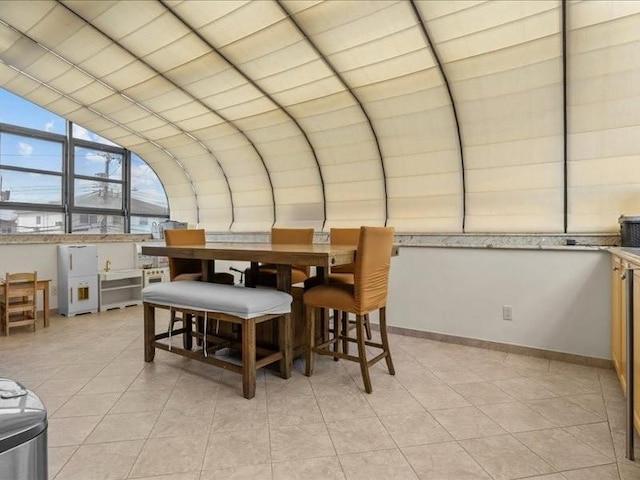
[142,280,292,319]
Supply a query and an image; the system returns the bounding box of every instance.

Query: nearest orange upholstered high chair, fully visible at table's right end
[303,227,395,393]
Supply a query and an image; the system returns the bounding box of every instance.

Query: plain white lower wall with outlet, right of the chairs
[387,247,611,358]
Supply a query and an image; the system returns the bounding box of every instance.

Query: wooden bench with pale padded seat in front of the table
[142,281,292,398]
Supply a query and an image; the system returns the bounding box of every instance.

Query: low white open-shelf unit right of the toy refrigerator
[98,269,142,312]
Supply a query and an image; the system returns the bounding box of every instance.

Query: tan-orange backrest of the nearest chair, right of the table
[354,227,394,314]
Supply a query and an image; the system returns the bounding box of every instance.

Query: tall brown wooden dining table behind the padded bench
[141,242,370,356]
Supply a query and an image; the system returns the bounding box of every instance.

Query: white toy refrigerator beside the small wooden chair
[58,245,98,317]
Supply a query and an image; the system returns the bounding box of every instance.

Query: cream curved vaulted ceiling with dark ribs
[0,0,640,232]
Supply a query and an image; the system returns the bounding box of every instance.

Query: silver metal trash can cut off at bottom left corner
[0,378,48,480]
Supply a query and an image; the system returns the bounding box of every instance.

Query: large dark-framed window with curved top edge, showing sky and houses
[0,88,169,233]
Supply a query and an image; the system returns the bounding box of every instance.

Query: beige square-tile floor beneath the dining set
[0,307,640,480]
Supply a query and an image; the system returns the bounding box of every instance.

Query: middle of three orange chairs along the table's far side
[245,228,313,287]
